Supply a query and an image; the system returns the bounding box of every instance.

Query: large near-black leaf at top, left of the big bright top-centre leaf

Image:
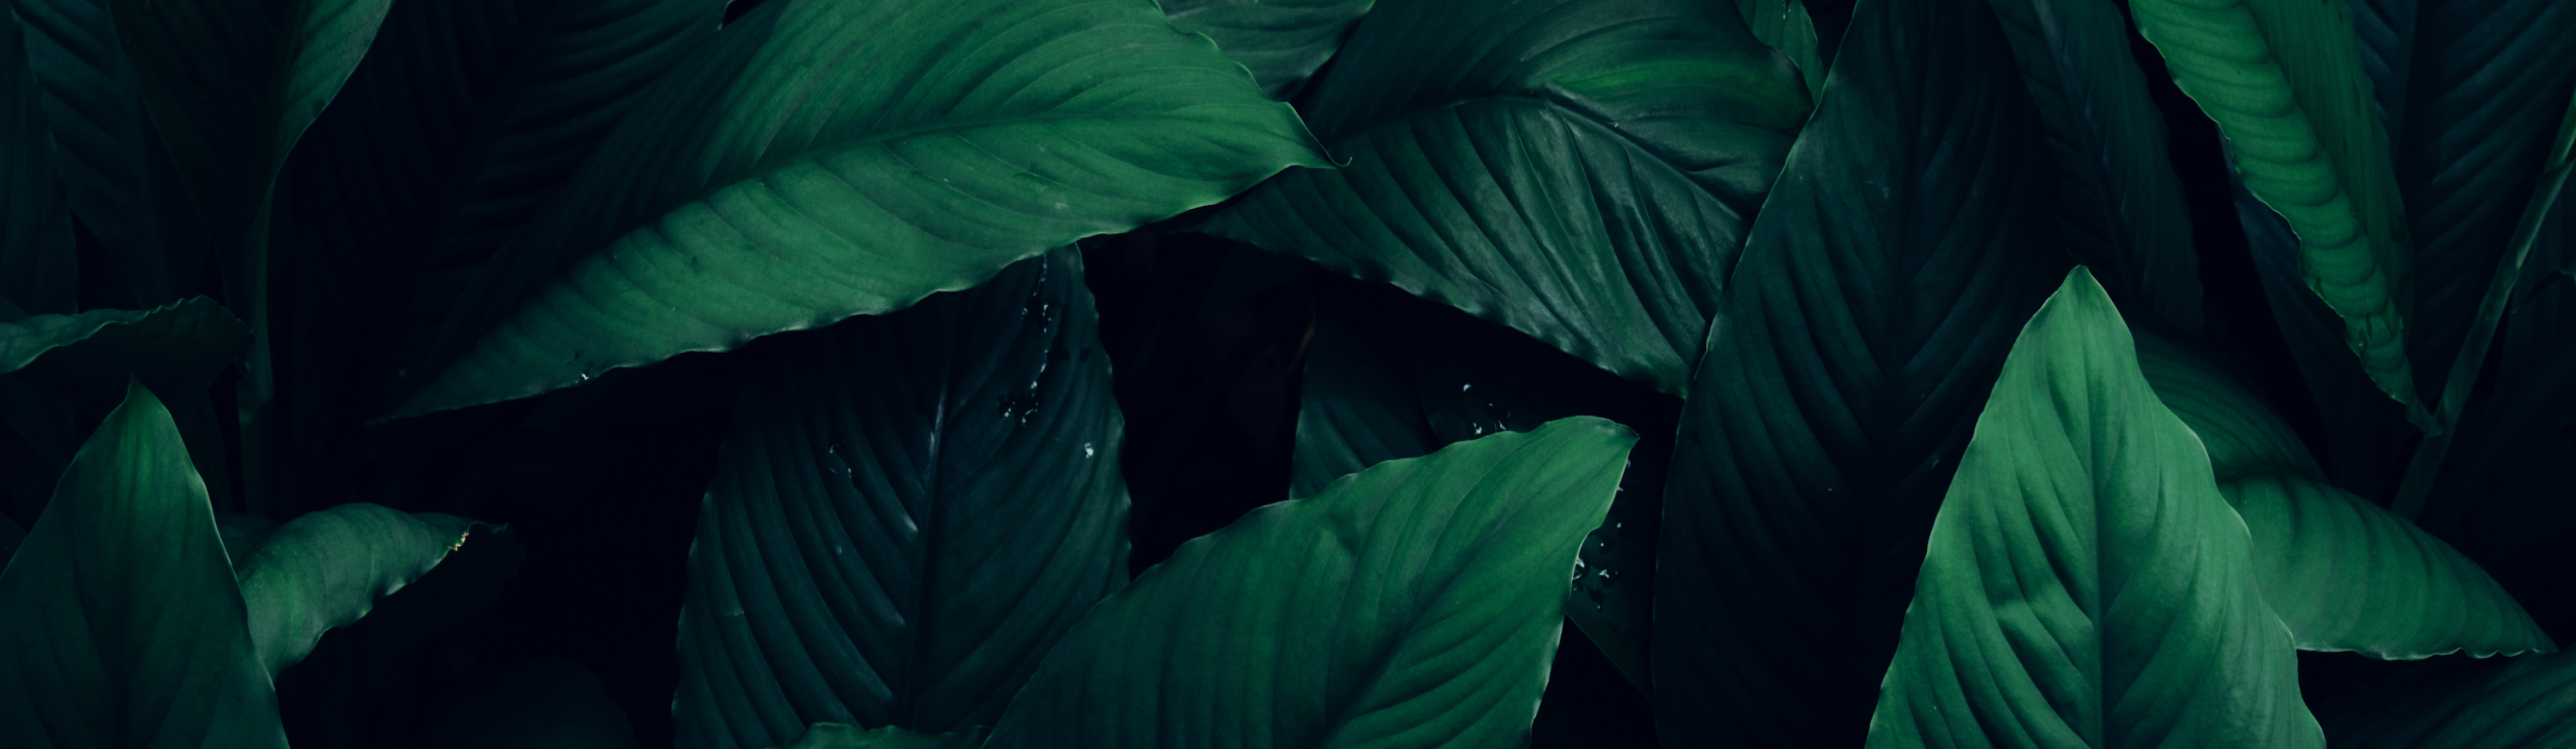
[268,0,724,507]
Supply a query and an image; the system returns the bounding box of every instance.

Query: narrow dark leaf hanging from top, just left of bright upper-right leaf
[1994,0,2200,332]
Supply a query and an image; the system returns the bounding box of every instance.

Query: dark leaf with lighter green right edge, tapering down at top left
[98,0,394,254]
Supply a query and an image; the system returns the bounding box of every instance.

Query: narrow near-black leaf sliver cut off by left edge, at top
[0,13,80,319]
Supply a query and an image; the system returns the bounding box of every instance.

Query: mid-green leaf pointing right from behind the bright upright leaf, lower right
[2218,476,2558,659]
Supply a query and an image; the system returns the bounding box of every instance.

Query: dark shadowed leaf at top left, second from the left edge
[10,0,206,306]
